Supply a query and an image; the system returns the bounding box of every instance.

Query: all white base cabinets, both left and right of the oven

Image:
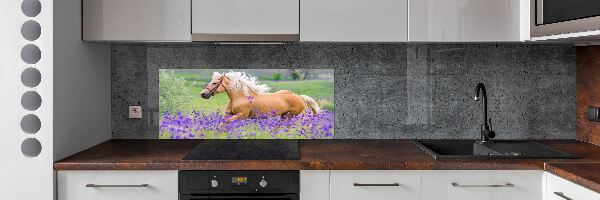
[57,170,600,200]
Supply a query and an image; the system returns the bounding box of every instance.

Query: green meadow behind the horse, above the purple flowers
[162,73,335,113]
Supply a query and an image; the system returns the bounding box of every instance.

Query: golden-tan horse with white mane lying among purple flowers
[200,72,320,121]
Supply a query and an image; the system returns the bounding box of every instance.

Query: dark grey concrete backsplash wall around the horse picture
[112,44,575,139]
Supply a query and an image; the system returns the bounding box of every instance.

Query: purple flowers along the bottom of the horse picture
[160,110,334,139]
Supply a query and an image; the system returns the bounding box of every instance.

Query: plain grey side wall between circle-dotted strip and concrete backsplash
[54,0,111,160]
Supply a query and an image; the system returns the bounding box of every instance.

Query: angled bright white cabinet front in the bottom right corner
[545,172,600,200]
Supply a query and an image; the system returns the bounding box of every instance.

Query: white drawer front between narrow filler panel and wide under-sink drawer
[330,170,421,200]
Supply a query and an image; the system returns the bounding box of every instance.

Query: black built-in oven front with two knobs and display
[179,171,300,200]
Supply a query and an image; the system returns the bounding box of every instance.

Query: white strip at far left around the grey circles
[0,0,53,200]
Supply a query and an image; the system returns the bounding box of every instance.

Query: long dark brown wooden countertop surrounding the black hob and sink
[54,140,600,170]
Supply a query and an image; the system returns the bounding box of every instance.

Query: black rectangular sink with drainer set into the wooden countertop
[412,140,578,159]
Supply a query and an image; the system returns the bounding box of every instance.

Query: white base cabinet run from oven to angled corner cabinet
[300,170,548,200]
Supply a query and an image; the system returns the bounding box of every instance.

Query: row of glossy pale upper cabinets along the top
[78,0,531,42]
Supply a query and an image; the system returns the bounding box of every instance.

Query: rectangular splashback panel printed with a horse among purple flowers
[159,69,335,139]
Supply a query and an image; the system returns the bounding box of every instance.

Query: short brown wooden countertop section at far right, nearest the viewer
[545,162,600,193]
